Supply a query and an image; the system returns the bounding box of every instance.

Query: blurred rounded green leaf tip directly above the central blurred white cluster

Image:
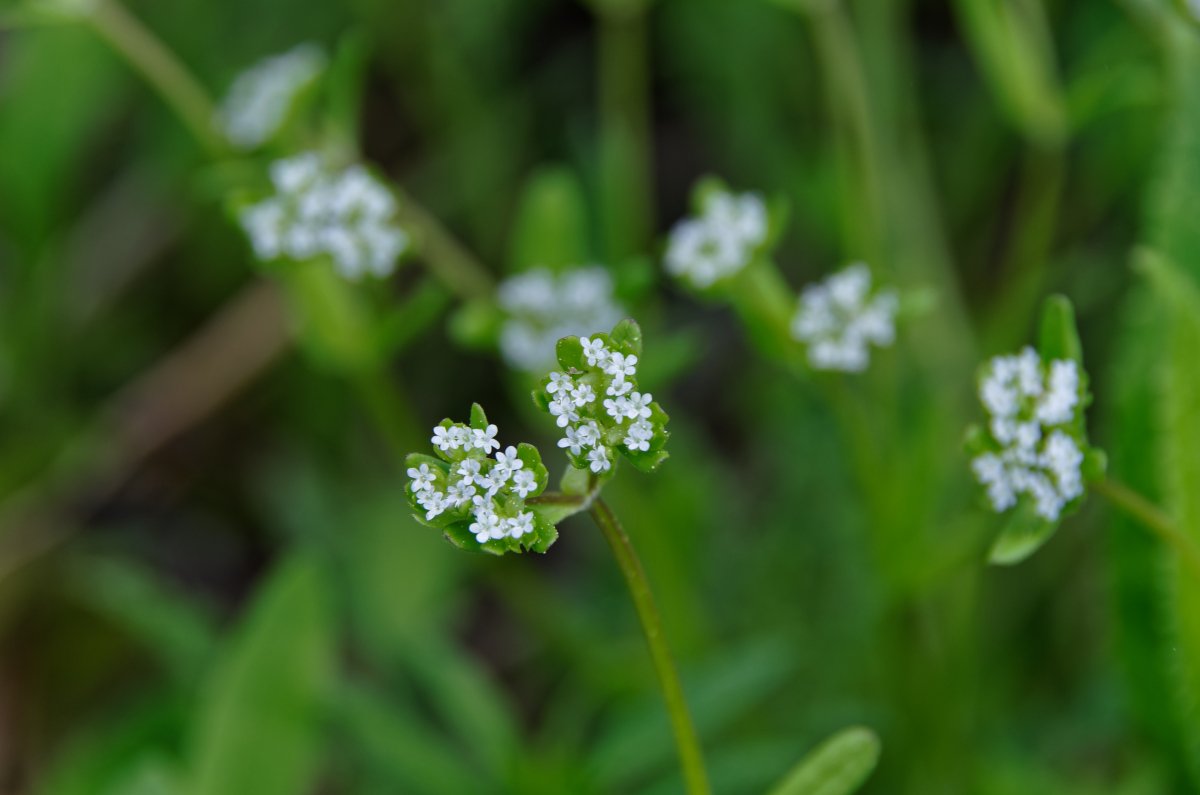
[509,166,589,273]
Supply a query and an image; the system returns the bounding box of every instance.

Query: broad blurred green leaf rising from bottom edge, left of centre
[190,554,335,795]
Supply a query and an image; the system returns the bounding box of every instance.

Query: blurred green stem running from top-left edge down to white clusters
[88,0,224,155]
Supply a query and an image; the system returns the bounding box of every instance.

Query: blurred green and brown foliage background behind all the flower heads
[0,0,1200,795]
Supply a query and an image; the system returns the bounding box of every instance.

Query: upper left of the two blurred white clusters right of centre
[666,191,767,289]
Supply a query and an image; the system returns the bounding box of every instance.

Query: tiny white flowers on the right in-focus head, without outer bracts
[545,337,658,474]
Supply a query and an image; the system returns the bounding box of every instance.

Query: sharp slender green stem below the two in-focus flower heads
[592,497,712,795]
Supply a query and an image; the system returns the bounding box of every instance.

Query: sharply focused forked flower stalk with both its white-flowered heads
[406,321,709,795]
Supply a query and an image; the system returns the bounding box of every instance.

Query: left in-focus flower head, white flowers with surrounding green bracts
[406,404,558,555]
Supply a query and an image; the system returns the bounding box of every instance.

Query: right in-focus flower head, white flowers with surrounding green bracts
[533,319,670,477]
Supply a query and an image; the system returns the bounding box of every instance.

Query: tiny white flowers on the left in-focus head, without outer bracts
[408,423,541,544]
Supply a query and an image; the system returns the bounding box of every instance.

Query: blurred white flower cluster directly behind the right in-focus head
[497,267,625,371]
